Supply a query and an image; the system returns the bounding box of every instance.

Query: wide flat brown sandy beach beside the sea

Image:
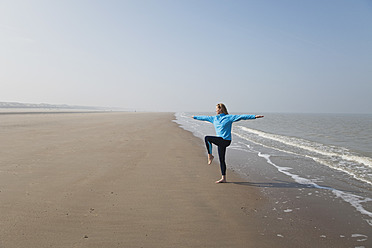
[0,112,370,248]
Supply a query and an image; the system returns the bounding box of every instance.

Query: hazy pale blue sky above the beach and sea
[0,0,372,113]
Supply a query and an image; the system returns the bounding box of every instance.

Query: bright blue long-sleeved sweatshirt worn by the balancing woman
[194,114,256,140]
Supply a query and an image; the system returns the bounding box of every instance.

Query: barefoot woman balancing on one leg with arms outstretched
[192,103,264,183]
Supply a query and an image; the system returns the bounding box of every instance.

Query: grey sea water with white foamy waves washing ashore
[175,113,372,226]
